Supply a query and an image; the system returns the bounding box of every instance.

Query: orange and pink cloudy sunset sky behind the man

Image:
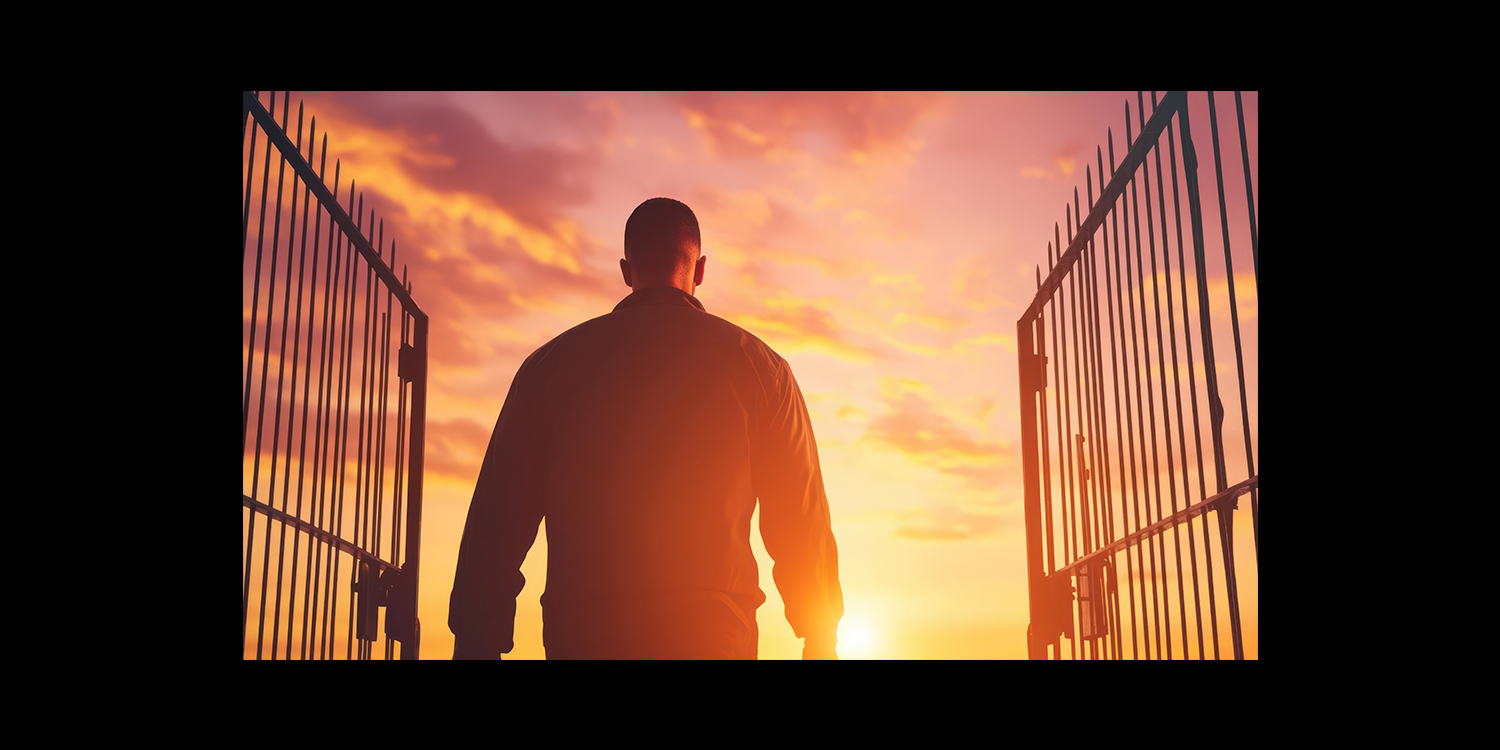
[243,92,1260,659]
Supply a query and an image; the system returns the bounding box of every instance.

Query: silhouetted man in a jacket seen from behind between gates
[449,198,843,659]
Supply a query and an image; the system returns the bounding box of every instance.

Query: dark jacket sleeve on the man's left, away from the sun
[449,351,543,659]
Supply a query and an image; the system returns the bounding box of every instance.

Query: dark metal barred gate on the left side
[240,92,428,659]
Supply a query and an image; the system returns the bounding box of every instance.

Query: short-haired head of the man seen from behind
[620,198,708,294]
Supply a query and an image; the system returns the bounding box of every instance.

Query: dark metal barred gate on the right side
[1016,92,1259,659]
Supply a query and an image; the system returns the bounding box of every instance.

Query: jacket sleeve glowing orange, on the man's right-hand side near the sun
[752,357,843,642]
